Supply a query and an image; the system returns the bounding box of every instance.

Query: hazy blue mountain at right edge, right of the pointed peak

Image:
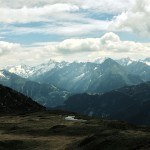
[126,61,150,81]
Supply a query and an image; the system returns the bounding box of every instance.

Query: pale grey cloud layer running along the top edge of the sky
[0,0,133,13]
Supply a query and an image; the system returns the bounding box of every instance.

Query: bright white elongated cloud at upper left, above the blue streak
[0,3,79,23]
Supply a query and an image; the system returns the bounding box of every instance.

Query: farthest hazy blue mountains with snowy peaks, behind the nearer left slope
[3,58,146,96]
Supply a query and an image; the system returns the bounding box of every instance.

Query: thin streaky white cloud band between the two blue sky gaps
[0,19,110,37]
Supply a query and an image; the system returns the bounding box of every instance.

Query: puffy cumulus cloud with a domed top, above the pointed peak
[45,32,150,54]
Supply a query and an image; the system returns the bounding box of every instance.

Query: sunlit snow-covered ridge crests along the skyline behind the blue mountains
[3,57,150,78]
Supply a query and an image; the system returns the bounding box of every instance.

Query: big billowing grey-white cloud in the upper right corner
[110,0,150,36]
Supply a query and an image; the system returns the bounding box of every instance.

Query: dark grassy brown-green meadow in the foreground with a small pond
[0,111,150,150]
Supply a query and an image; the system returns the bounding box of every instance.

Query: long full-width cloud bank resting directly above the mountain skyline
[0,32,150,65]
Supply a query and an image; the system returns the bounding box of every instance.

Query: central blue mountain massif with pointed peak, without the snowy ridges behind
[32,58,142,93]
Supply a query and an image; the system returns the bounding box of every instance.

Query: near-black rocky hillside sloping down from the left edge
[0,85,45,114]
